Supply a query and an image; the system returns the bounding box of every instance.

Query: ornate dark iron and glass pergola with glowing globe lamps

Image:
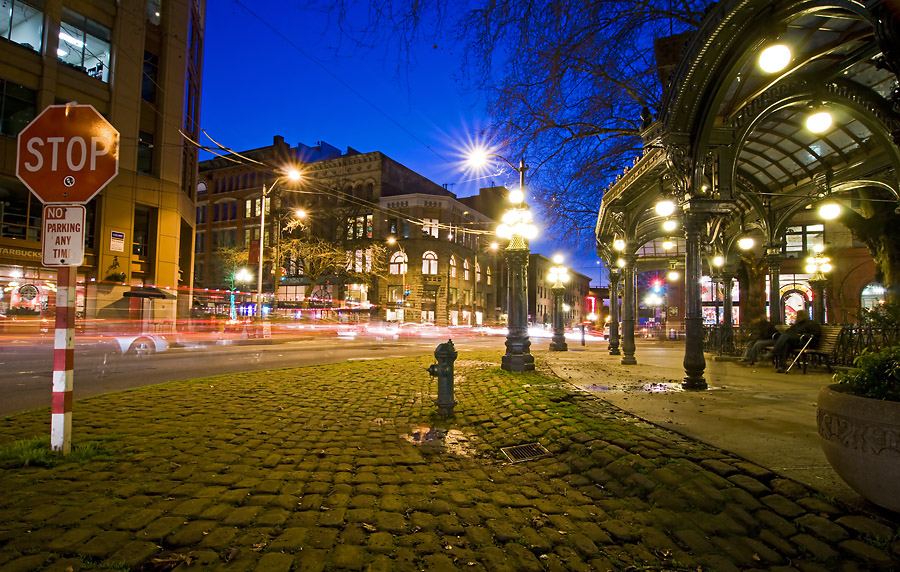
[596,0,900,389]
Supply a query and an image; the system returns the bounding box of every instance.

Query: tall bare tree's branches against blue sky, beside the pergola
[312,0,712,249]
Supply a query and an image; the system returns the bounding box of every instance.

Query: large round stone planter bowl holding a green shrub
[817,384,900,512]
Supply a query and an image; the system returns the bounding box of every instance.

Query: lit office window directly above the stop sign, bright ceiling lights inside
[56,7,111,82]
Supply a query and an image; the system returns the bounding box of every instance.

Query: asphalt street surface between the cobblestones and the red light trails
[0,330,504,416]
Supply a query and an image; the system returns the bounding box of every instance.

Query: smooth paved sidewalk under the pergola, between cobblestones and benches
[547,339,856,506]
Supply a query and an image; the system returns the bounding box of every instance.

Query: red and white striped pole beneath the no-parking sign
[50,266,78,455]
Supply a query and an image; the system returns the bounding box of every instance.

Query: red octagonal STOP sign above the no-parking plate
[16,105,119,204]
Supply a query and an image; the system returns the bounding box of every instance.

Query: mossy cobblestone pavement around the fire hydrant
[0,352,900,572]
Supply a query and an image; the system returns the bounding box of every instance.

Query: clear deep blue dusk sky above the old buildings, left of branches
[200,0,605,285]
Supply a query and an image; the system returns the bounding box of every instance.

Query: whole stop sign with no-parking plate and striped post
[16,104,119,455]
